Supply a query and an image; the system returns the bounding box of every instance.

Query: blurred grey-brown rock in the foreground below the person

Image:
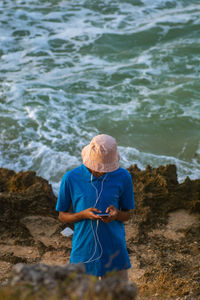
[11,264,137,300]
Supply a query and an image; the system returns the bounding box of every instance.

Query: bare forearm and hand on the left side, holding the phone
[58,207,101,223]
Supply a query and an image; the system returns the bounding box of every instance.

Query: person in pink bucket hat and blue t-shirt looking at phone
[56,134,135,279]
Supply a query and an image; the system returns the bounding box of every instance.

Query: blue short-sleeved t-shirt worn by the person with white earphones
[56,164,135,276]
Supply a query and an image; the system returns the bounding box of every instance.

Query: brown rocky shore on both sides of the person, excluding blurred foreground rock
[0,165,200,300]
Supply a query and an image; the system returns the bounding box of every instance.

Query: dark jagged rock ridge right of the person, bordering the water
[128,165,200,239]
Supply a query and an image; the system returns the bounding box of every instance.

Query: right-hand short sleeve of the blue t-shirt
[119,170,135,210]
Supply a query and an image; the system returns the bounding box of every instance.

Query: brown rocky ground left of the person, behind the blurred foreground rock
[0,168,71,282]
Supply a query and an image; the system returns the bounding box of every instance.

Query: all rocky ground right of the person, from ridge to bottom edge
[127,165,200,299]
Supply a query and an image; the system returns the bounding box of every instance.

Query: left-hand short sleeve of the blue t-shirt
[56,173,71,211]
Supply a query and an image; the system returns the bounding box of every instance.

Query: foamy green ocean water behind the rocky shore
[0,0,200,193]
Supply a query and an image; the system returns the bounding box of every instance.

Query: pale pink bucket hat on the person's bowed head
[82,134,120,172]
